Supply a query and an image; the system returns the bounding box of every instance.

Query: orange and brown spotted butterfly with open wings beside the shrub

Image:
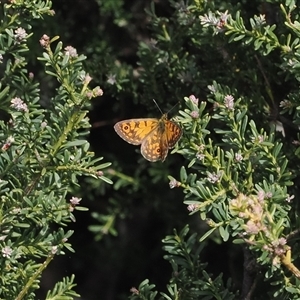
[114,114,182,162]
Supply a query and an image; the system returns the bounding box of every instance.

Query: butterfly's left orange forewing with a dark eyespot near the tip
[114,118,158,145]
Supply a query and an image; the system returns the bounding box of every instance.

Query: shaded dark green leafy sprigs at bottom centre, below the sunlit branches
[130,226,235,300]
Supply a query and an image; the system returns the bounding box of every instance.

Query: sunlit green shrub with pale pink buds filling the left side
[0,1,110,299]
